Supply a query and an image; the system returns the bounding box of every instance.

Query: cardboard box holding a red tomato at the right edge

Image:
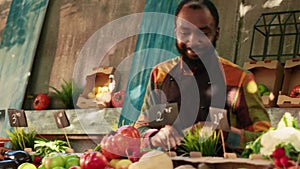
[277,59,300,108]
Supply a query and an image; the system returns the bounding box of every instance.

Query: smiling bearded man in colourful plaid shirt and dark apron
[135,0,271,153]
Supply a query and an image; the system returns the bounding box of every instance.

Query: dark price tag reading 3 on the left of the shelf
[8,109,27,127]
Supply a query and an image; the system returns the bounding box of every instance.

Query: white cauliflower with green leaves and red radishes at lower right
[242,112,300,169]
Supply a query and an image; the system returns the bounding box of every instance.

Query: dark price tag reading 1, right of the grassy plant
[209,107,230,131]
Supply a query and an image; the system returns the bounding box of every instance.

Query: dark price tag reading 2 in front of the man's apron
[148,103,178,127]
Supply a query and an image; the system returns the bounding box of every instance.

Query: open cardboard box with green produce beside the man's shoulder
[244,60,283,107]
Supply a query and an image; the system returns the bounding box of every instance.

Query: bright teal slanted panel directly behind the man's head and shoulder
[119,0,180,126]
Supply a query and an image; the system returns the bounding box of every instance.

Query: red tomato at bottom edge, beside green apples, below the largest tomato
[80,152,108,169]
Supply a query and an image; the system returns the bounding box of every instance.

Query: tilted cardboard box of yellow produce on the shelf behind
[77,66,115,109]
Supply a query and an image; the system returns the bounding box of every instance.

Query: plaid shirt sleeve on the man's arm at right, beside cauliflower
[229,72,271,148]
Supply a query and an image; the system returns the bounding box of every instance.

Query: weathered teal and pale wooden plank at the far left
[0,0,48,137]
